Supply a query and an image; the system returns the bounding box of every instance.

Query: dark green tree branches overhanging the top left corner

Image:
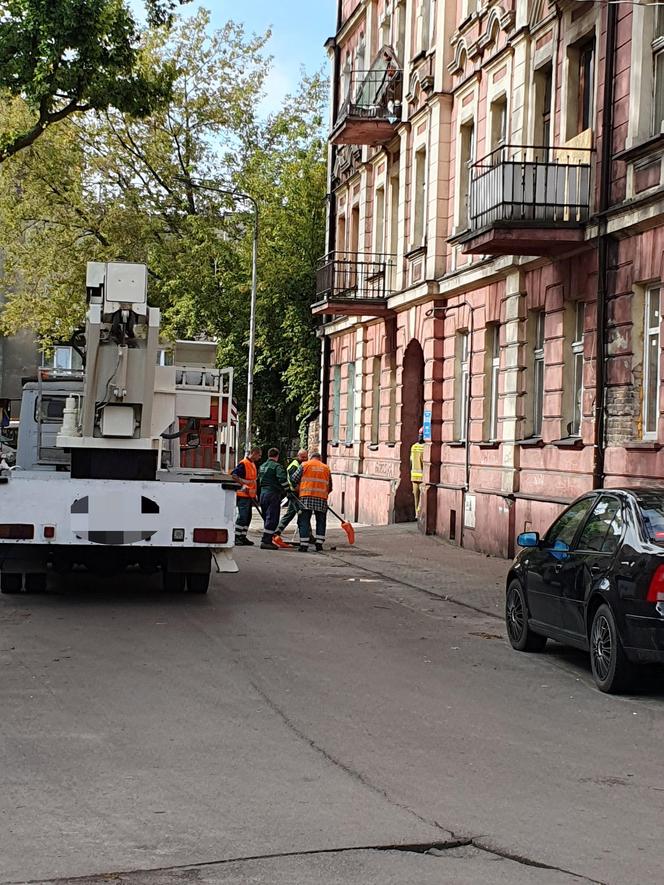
[0,0,179,163]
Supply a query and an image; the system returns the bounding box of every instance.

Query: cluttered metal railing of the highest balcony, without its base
[335,67,403,126]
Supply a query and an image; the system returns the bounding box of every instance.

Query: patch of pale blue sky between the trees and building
[152,0,337,113]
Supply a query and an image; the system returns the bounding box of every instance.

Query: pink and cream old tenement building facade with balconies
[313,0,664,556]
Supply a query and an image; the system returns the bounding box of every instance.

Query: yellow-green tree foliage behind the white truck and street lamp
[0,6,326,444]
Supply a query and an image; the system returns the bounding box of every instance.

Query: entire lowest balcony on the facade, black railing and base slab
[311,252,395,317]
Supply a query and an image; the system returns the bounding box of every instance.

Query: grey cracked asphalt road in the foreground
[0,549,664,885]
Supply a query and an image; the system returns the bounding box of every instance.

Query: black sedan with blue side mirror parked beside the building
[505,488,664,692]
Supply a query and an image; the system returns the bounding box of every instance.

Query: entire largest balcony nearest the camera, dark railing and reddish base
[457,145,592,256]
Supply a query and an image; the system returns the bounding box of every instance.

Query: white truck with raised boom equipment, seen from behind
[0,262,237,593]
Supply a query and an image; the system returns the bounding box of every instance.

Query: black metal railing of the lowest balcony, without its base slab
[316,252,395,301]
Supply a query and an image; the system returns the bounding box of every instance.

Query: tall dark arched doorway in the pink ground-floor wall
[394,338,424,522]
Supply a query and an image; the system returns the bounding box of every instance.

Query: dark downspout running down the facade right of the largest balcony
[593,3,618,489]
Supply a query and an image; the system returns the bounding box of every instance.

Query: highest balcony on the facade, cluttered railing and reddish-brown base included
[330,64,403,146]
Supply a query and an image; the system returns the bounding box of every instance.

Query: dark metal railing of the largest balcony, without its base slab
[469,145,592,230]
